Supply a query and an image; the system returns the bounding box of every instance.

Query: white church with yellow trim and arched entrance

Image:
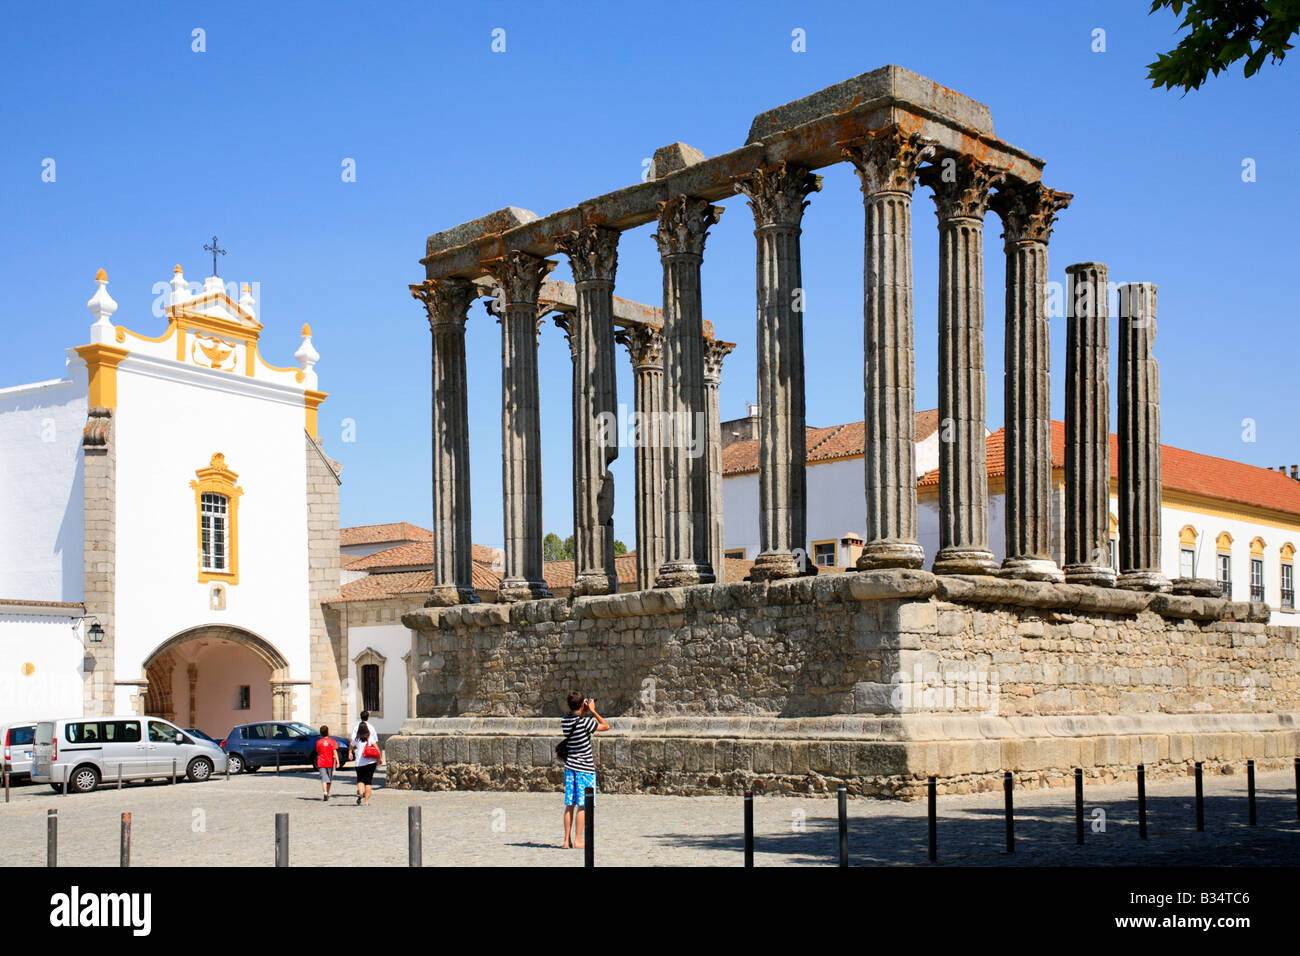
[0,265,347,736]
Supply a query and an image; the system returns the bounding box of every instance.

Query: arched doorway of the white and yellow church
[144,624,293,740]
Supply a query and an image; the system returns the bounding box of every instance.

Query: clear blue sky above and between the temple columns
[0,0,1300,546]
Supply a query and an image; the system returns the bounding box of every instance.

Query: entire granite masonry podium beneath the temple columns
[386,570,1300,797]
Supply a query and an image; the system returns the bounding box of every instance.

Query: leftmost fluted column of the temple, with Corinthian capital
[411,278,478,607]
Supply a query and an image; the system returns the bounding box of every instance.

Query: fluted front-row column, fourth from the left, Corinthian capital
[655,196,723,588]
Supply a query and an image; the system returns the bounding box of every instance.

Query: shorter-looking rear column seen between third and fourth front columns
[619,325,664,591]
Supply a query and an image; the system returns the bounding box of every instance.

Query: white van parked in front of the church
[31,714,226,793]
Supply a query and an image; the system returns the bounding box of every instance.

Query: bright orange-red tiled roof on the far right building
[918,421,1300,515]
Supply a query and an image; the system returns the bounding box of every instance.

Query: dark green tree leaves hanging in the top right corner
[1147,0,1300,90]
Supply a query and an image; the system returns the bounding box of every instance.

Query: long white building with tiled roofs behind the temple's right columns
[723,410,1300,624]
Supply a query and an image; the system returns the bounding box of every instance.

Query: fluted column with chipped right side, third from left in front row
[555,225,619,594]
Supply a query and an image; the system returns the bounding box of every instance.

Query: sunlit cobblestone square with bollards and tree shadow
[0,770,1300,866]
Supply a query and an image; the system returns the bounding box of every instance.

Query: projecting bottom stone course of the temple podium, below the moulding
[386,714,1300,800]
